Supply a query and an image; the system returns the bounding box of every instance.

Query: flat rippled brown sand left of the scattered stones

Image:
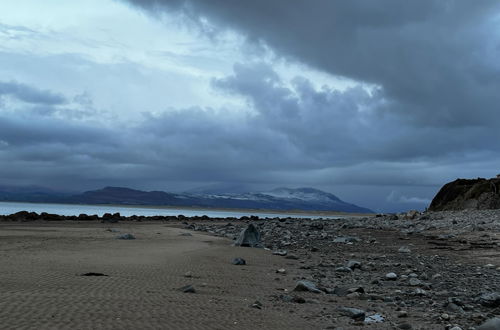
[0,222,310,329]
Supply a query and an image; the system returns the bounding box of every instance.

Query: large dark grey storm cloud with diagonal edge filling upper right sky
[123,0,500,127]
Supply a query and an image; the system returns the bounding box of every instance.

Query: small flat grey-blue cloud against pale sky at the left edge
[0,81,66,105]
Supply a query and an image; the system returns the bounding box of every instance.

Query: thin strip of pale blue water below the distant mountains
[0,202,339,219]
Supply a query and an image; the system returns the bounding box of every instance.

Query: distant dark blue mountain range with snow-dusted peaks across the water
[0,187,373,213]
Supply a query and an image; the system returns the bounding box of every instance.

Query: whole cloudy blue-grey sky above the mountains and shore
[0,0,500,212]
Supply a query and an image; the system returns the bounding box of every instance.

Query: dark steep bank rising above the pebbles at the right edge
[429,177,500,211]
